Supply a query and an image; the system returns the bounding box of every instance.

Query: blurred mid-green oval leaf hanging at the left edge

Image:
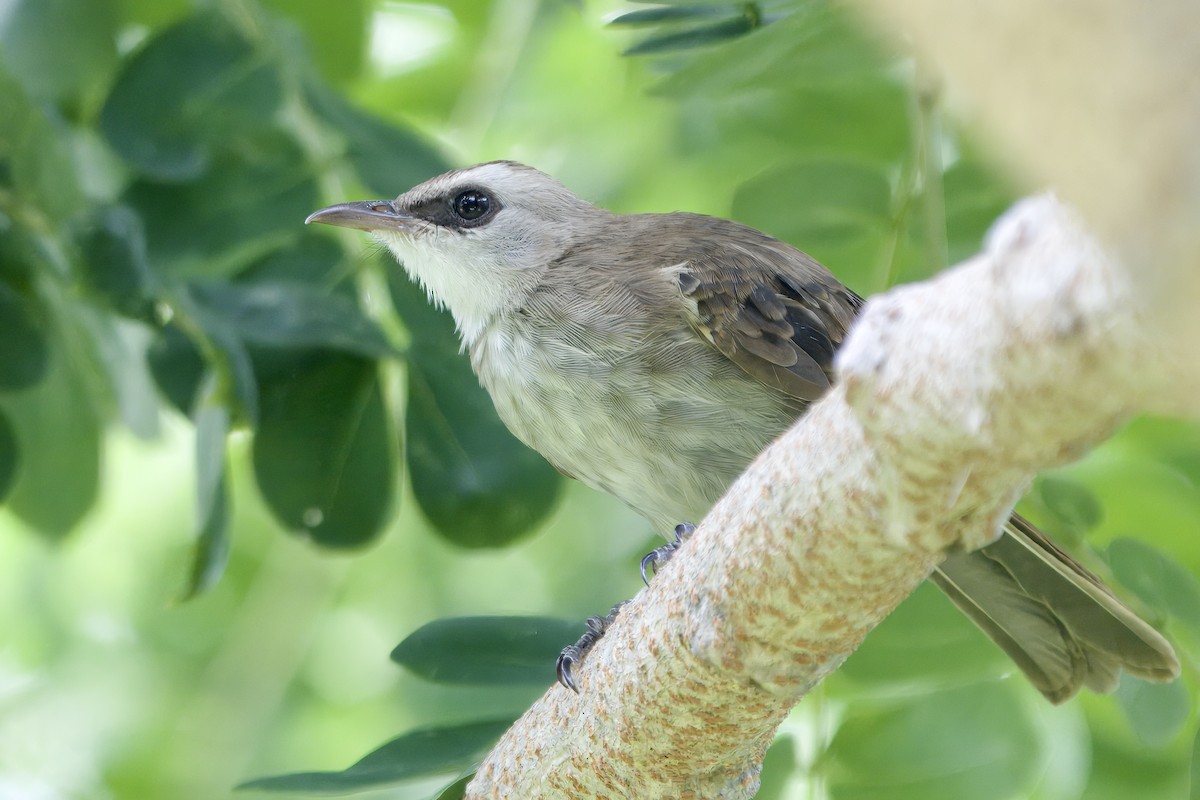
[0,335,102,539]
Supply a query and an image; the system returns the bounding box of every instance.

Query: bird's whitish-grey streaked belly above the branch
[472,321,798,535]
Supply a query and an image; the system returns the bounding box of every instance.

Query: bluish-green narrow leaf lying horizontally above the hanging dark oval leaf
[193,282,396,357]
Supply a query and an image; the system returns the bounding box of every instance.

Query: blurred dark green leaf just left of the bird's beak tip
[124,134,318,279]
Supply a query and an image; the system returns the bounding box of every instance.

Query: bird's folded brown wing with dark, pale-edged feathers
[678,223,863,402]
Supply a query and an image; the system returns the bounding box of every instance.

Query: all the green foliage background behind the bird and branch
[0,0,1200,800]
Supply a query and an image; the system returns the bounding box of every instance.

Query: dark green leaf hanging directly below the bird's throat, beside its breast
[391,271,560,547]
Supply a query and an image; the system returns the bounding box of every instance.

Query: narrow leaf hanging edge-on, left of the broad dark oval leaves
[184,373,229,600]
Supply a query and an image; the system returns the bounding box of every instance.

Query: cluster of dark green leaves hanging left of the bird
[0,0,558,556]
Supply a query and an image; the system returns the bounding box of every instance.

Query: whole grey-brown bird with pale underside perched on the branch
[306,161,1180,703]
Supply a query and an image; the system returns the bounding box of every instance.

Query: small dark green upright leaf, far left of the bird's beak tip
[77,206,154,320]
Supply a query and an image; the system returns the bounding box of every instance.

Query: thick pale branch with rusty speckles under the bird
[468,197,1195,798]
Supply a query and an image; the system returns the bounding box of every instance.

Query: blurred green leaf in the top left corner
[0,0,116,100]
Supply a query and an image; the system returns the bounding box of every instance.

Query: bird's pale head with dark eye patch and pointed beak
[306,161,595,344]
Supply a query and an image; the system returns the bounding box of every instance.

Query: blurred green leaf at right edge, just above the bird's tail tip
[1108,539,1200,637]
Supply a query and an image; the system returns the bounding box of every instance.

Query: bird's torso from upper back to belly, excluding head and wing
[470,215,806,533]
